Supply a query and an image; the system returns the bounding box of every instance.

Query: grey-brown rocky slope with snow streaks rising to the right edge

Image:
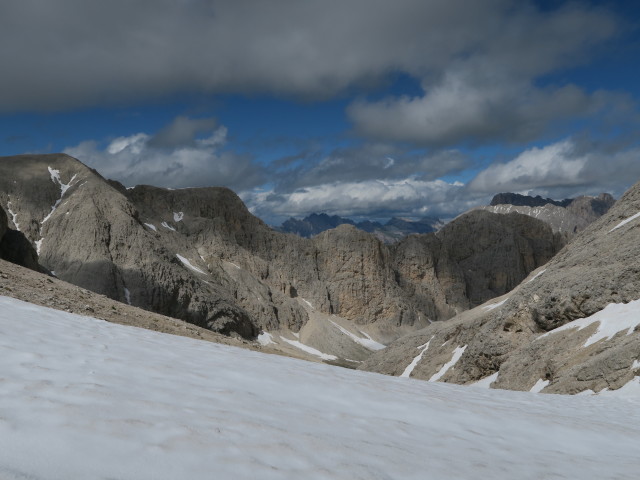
[361,183,640,394]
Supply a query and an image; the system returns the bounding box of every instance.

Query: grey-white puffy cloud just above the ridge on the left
[65,117,265,190]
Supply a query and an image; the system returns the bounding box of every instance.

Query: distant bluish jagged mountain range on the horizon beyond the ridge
[276,213,444,244]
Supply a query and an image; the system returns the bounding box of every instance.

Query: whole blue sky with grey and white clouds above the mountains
[0,0,640,225]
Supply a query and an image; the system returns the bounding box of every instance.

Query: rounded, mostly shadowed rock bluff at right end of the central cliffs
[394,210,565,320]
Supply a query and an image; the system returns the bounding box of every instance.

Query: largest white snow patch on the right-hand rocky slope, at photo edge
[538,300,640,347]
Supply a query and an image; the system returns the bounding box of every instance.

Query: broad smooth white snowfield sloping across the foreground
[0,297,640,480]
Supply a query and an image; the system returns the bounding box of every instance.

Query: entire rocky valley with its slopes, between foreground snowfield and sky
[0,154,640,394]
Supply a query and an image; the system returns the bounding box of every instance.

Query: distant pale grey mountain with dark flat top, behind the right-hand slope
[478,193,615,235]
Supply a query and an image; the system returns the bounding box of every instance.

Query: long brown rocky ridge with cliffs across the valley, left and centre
[0,155,562,362]
